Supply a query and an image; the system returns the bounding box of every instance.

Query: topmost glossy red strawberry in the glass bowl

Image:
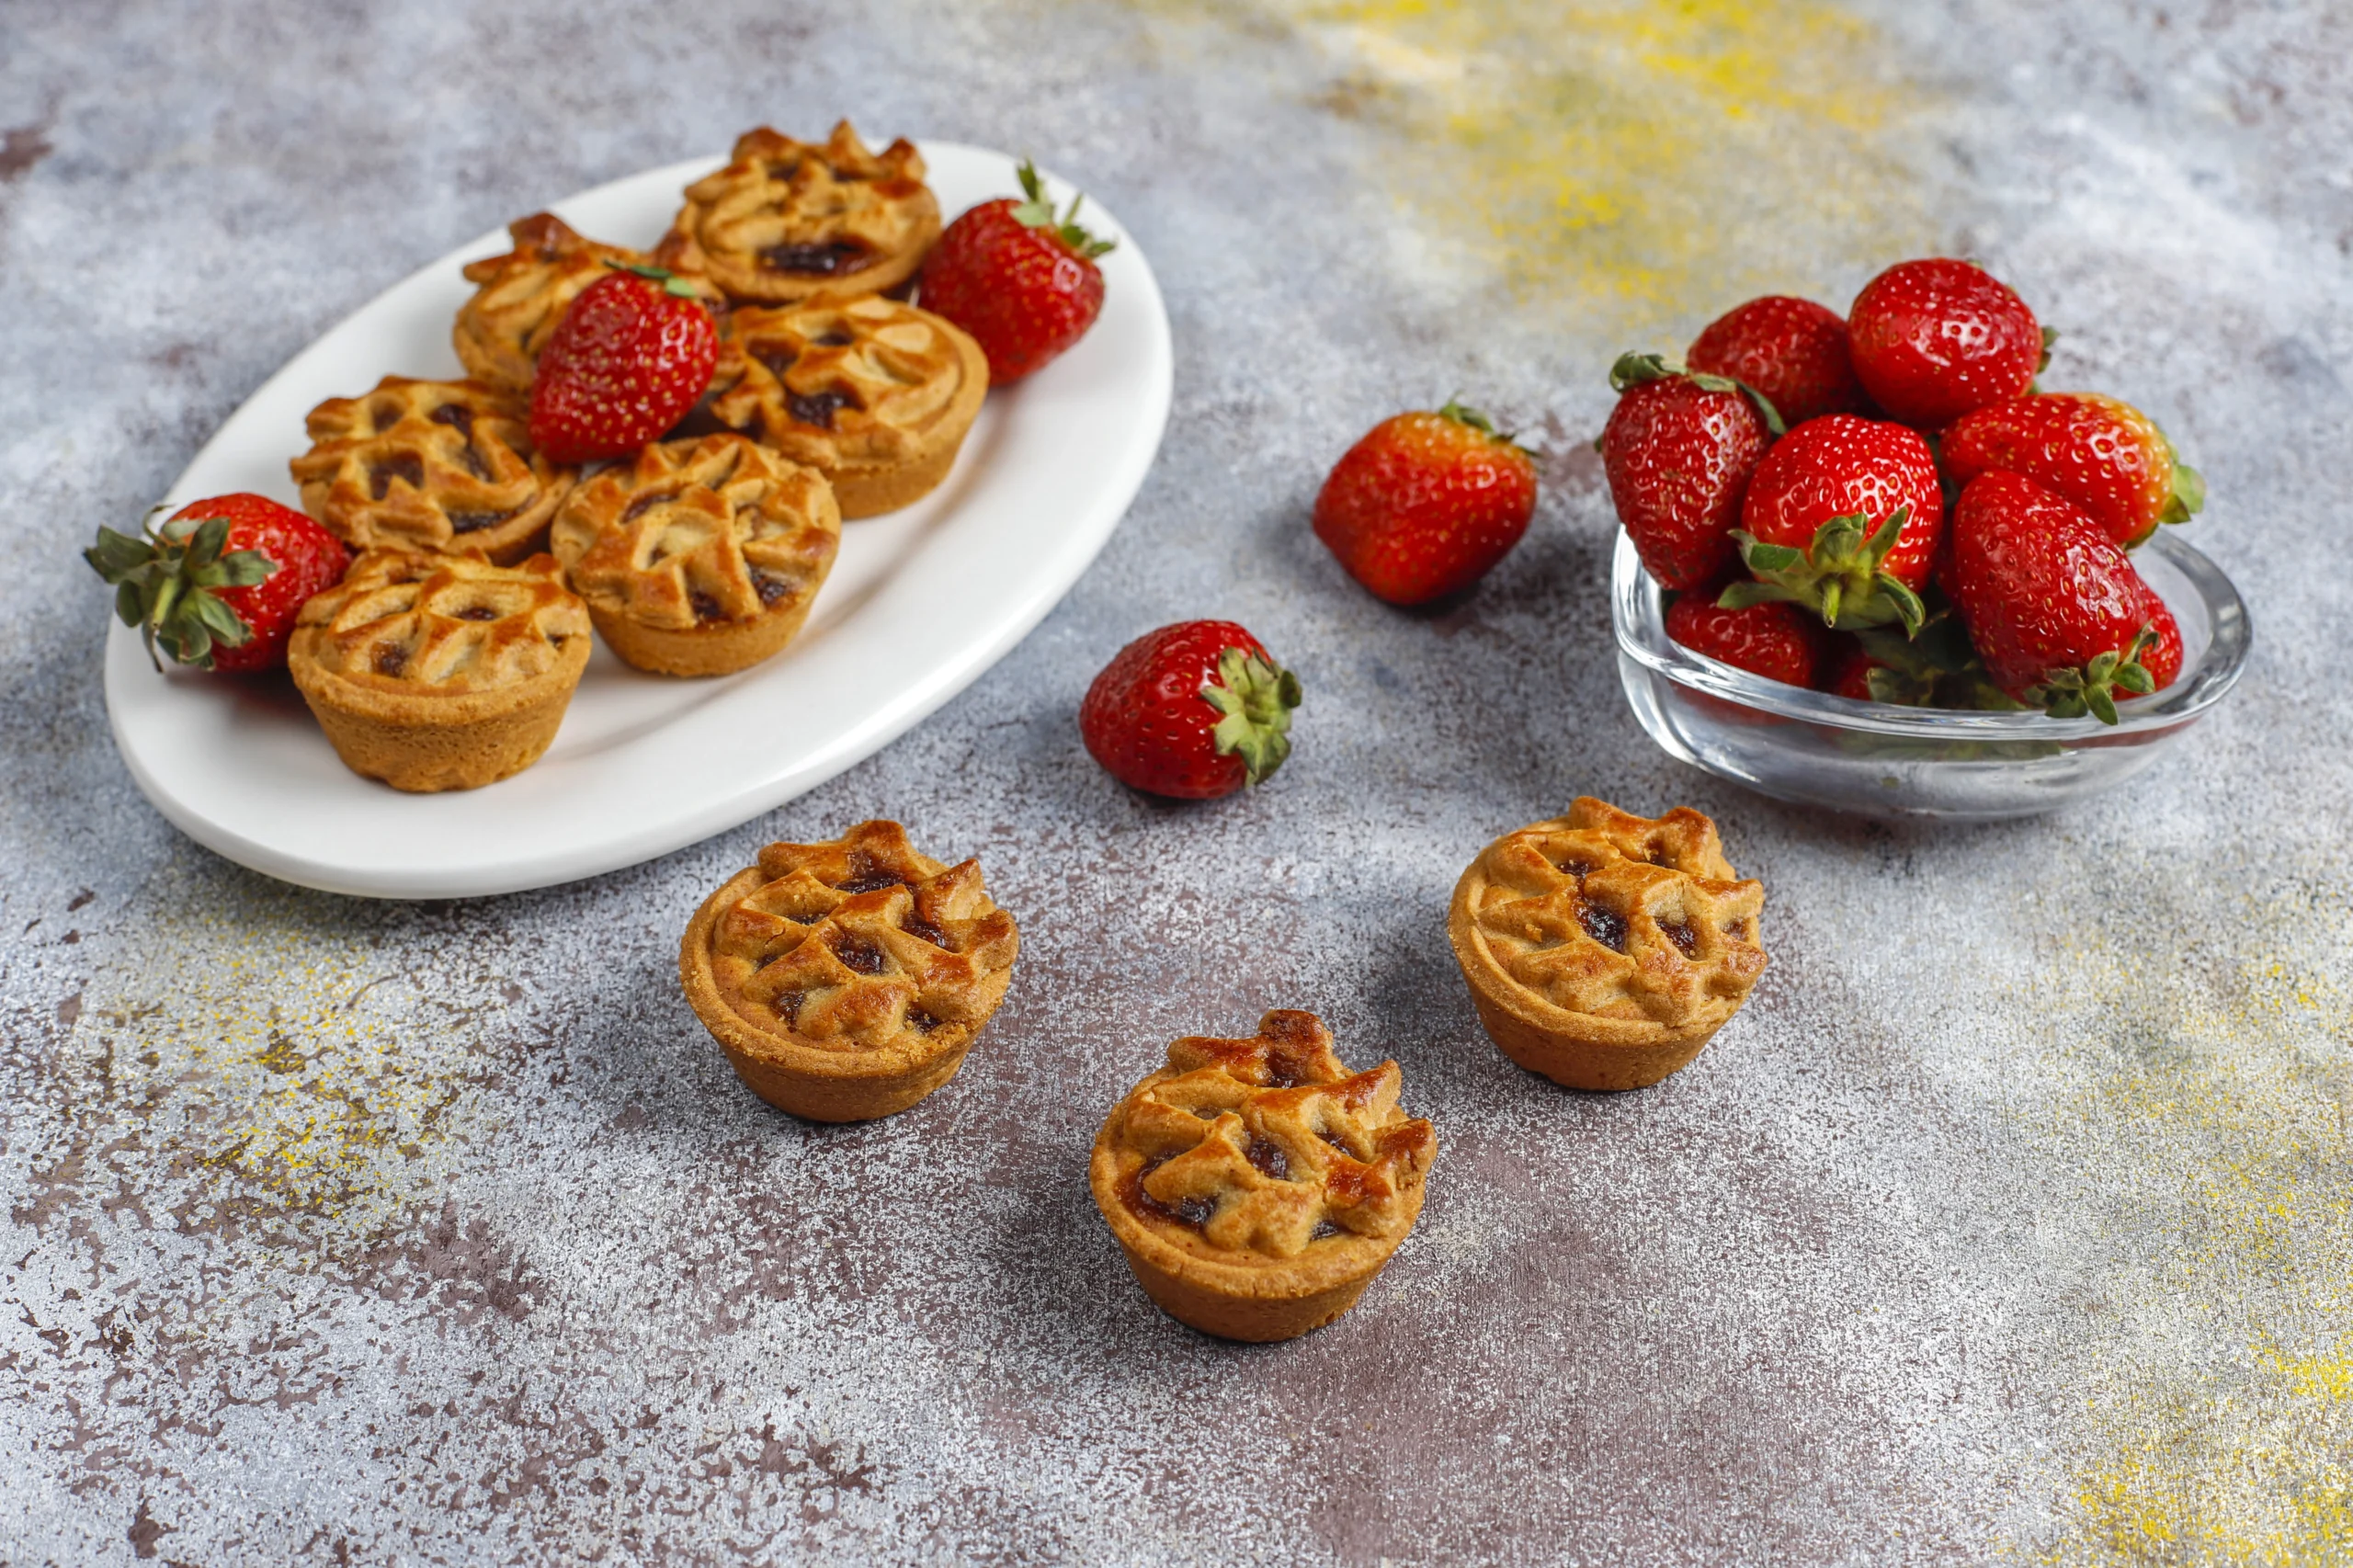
[1847,259,2047,431]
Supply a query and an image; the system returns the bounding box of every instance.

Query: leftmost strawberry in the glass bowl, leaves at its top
[1600,353,1772,591]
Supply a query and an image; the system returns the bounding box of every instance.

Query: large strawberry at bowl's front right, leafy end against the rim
[1953,471,2181,725]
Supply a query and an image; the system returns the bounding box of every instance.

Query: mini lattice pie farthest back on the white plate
[654,120,938,303]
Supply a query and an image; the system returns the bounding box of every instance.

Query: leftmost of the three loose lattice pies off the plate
[677,822,1021,1120]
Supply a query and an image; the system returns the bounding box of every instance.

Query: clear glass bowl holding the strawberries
[1609,529,2252,822]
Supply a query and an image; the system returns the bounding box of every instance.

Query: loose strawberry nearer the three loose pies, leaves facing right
[1077,621,1299,801]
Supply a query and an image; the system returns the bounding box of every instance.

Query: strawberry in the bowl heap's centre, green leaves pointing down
[1724,415,1944,631]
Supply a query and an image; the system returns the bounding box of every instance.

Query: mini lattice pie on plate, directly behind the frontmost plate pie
[287,377,574,565]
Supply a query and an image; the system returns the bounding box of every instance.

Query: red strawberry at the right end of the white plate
[920,163,1113,386]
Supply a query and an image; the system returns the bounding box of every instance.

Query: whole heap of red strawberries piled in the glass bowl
[1600,259,2205,722]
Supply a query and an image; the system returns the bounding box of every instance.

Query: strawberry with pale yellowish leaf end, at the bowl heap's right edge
[1938,393,2205,549]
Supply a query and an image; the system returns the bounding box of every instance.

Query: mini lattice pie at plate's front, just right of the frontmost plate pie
[551,436,842,676]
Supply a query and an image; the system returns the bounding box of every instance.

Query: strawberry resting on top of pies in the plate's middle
[532,261,720,464]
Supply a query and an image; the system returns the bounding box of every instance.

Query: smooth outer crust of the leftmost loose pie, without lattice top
[677,867,1012,1120]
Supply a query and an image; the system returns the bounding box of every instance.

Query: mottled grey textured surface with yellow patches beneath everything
[0,0,2353,1568]
